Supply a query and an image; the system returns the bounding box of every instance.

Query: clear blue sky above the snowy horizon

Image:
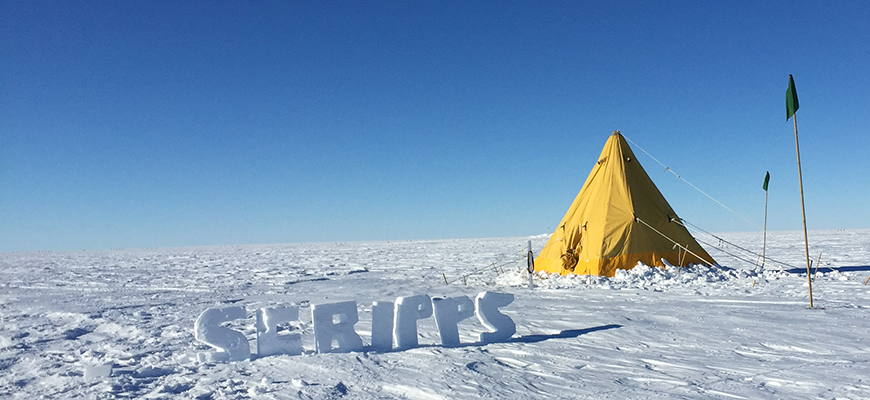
[0,1,870,251]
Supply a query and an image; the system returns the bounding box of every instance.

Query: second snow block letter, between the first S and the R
[257,306,302,357]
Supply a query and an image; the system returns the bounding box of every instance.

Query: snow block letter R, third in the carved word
[311,301,363,353]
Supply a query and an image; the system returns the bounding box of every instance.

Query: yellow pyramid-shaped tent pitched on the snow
[535,131,715,276]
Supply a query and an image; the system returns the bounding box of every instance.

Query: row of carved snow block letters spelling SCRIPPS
[194,292,517,362]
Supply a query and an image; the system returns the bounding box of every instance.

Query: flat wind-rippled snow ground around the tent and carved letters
[0,230,870,399]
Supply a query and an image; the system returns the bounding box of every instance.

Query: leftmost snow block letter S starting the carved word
[193,307,251,362]
